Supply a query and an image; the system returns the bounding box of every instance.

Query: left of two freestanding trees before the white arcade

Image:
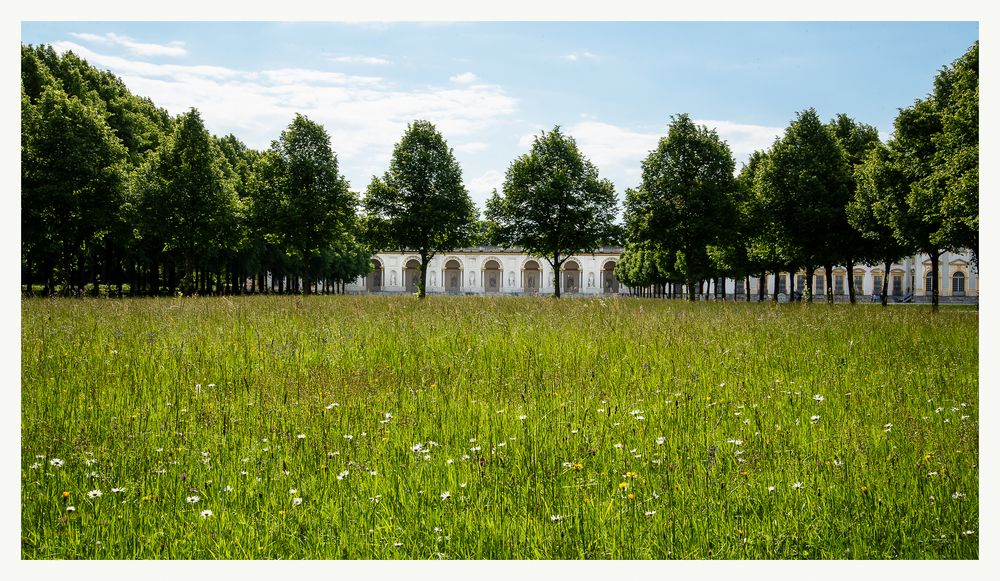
[364,120,478,298]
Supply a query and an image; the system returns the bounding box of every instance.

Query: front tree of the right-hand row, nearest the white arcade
[640,114,737,301]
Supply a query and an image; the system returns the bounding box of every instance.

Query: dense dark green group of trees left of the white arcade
[21,45,371,294]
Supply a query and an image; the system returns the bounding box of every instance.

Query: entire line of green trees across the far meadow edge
[21,42,979,307]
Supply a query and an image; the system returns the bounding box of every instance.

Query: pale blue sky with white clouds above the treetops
[21,21,979,214]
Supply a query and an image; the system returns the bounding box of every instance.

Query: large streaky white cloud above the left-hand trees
[53,42,517,190]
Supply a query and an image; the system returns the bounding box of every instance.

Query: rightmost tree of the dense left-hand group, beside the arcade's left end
[270,114,357,294]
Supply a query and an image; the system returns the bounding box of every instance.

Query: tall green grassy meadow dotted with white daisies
[20,296,979,559]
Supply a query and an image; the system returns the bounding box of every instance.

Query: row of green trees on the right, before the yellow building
[616,43,979,308]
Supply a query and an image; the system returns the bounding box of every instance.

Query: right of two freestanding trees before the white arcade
[486,125,619,298]
